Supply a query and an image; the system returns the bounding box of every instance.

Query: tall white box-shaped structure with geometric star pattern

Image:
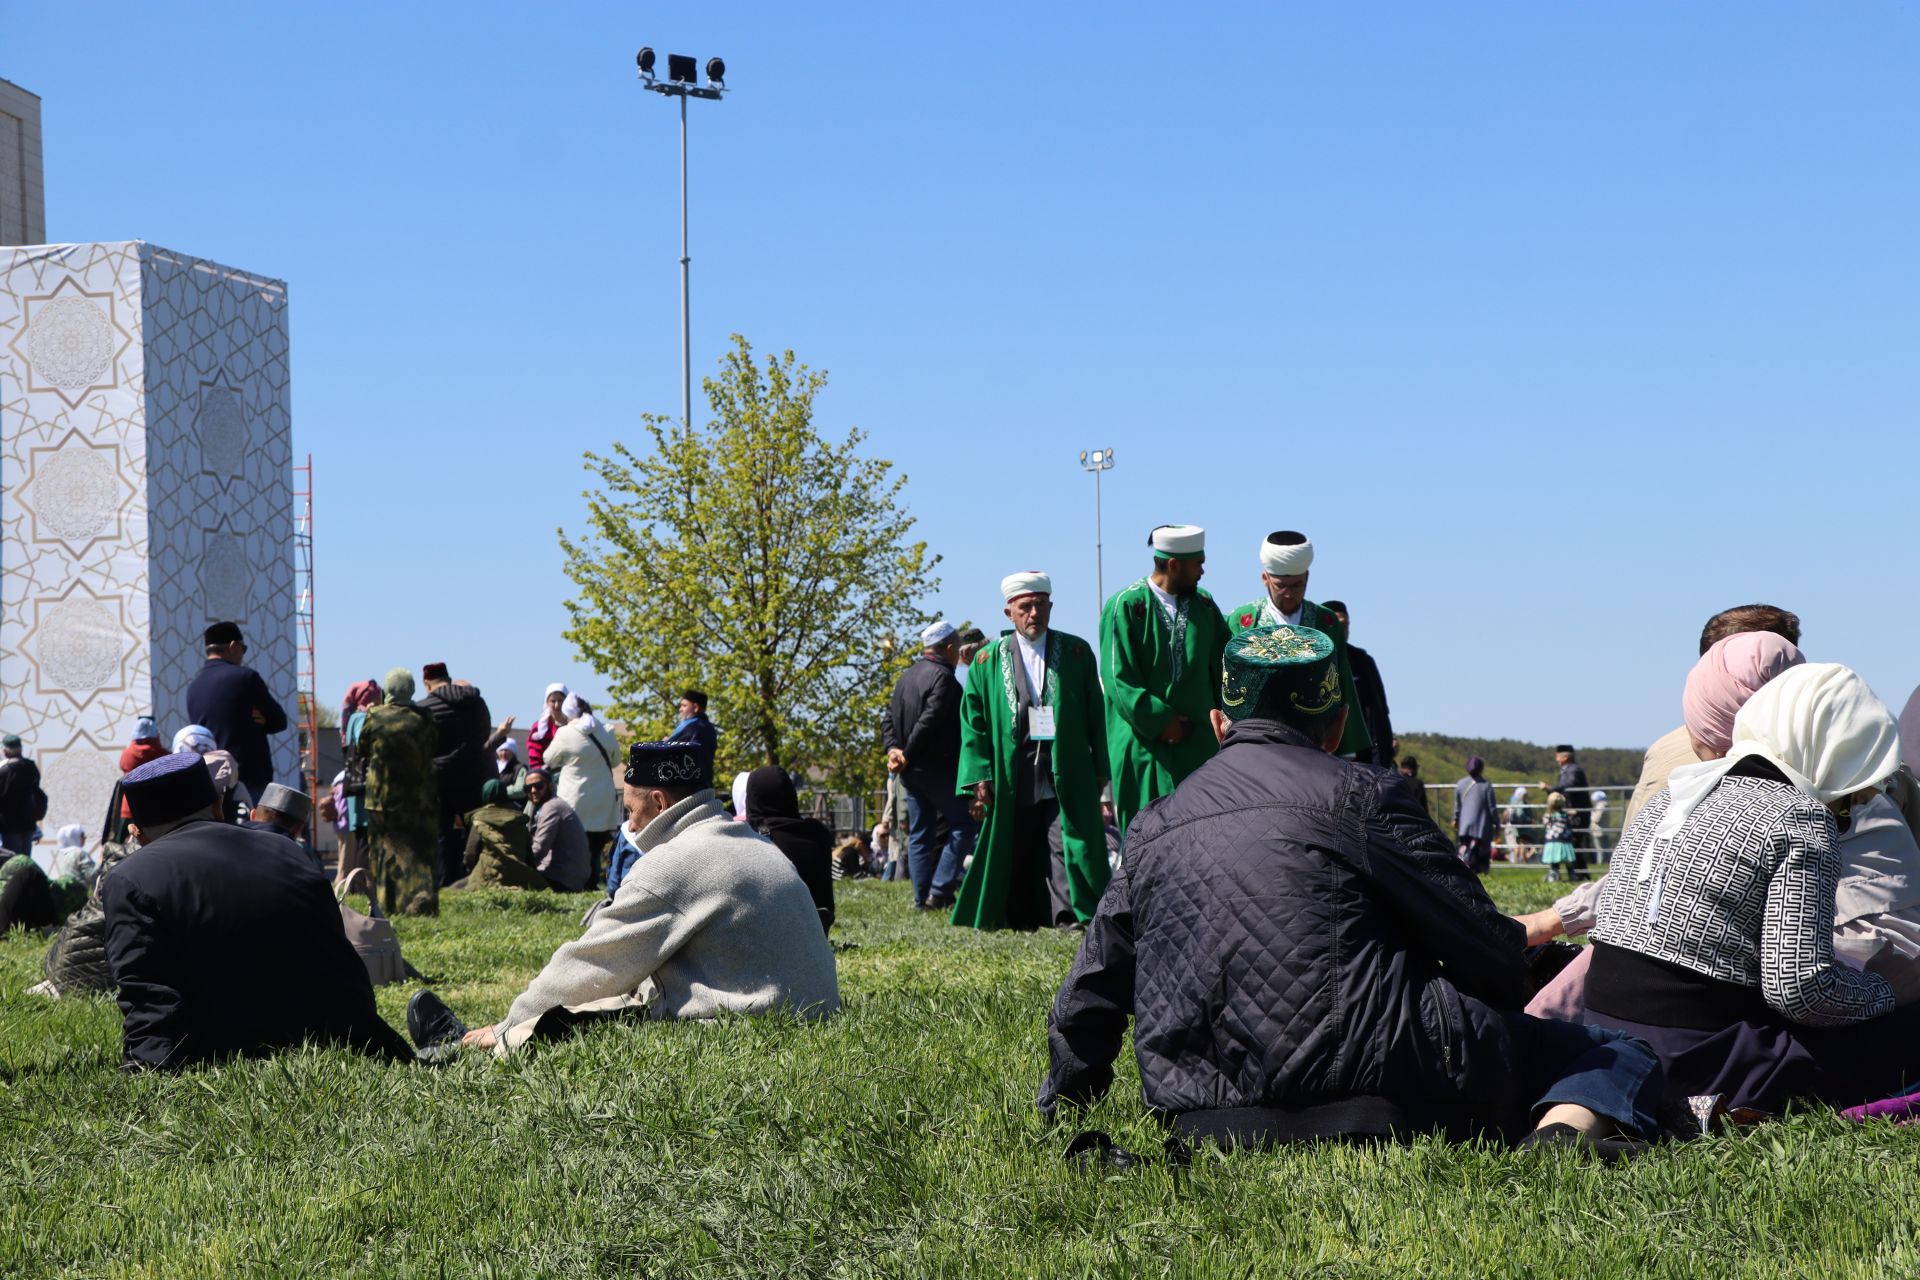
[0,242,298,835]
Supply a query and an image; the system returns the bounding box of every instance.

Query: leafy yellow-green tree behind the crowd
[559,334,939,791]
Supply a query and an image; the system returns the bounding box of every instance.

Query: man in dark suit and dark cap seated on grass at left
[104,752,413,1071]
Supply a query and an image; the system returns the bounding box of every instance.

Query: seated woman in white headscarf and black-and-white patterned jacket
[1586,662,1920,1111]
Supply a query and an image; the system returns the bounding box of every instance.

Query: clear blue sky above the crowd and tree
[0,0,1920,747]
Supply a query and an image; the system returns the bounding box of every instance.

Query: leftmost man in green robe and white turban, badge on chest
[952,570,1112,929]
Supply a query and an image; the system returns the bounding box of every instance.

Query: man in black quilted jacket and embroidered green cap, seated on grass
[1039,626,1663,1155]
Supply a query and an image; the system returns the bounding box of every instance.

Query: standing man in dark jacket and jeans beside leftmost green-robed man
[881,622,977,912]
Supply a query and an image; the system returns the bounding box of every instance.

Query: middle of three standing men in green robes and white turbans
[1100,524,1227,839]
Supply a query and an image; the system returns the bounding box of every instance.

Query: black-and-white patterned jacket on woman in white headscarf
[1592,775,1893,1027]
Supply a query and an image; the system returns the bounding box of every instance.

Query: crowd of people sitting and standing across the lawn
[0,541,1920,1157]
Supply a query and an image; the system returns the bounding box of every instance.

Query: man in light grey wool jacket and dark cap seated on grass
[407,743,839,1057]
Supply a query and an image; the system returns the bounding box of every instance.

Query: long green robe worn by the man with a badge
[952,629,1112,929]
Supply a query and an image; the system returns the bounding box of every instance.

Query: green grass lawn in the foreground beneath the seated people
[0,869,1920,1278]
